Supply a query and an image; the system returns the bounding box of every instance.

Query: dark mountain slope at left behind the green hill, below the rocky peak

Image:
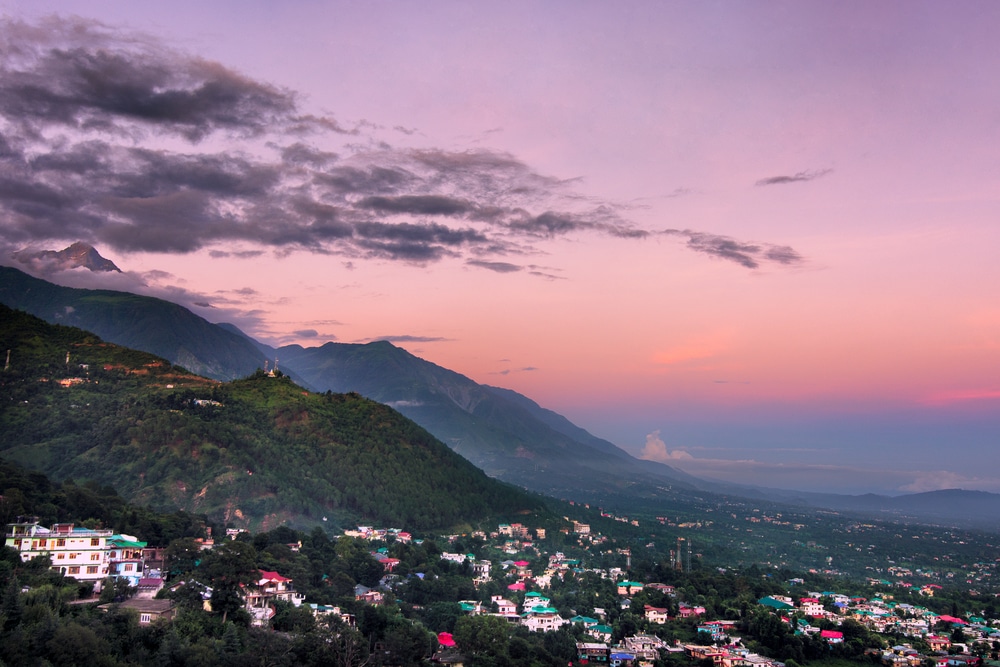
[0,266,264,380]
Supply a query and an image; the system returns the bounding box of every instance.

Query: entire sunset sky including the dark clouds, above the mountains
[0,0,1000,494]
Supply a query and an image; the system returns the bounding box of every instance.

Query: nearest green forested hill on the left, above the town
[0,306,544,529]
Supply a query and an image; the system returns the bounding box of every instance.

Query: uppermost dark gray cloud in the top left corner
[0,17,297,141]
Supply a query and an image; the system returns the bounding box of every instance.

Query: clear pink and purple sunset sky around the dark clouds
[0,1,1000,491]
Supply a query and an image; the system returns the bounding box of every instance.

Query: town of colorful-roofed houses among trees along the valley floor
[0,512,1000,667]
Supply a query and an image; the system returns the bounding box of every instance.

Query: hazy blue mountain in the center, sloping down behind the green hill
[275,341,698,502]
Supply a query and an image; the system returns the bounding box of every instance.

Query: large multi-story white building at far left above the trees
[4,521,146,586]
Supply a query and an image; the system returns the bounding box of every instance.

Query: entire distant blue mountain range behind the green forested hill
[0,267,1000,529]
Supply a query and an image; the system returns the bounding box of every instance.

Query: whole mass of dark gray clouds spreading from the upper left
[0,17,800,278]
